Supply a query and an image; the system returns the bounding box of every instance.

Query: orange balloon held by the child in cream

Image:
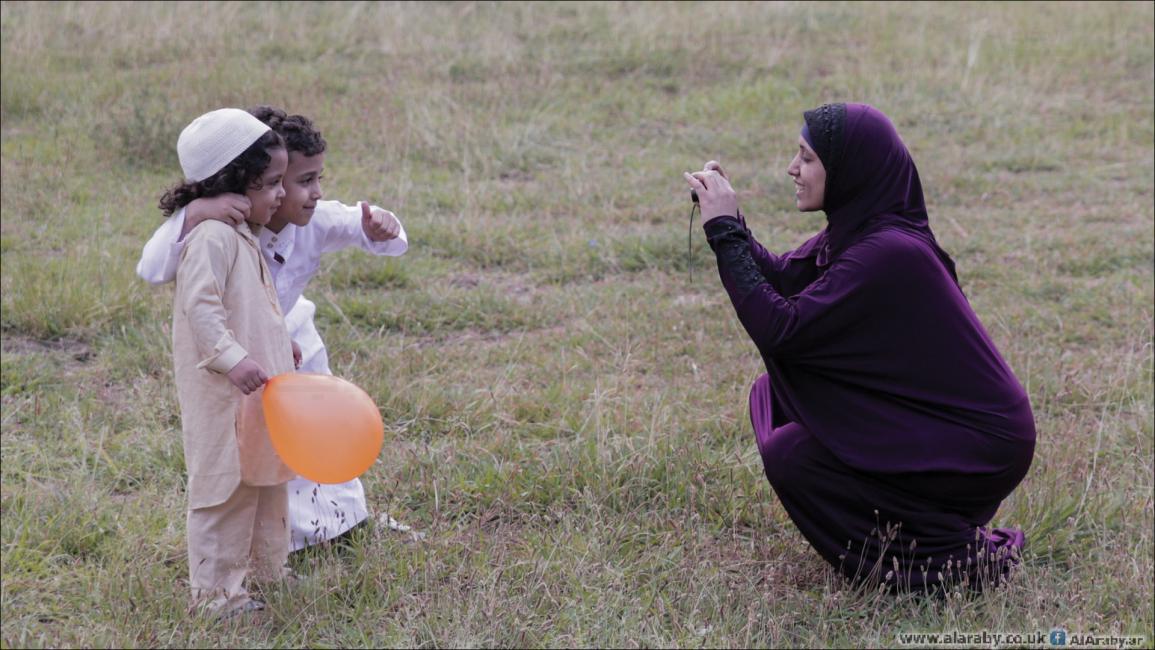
[261,373,385,483]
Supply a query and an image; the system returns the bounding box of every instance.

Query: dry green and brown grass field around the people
[0,2,1155,648]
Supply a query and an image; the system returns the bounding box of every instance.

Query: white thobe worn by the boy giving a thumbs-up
[136,201,409,551]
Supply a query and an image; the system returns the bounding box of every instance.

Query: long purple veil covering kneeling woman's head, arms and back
[706,104,1035,473]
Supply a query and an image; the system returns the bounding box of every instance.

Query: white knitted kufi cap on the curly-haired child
[177,109,269,182]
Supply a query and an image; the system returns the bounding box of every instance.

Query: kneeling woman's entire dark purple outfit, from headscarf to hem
[703,104,1035,589]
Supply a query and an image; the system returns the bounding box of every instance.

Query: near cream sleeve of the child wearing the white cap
[176,225,248,374]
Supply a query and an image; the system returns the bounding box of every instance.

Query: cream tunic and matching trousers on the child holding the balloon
[172,221,293,611]
